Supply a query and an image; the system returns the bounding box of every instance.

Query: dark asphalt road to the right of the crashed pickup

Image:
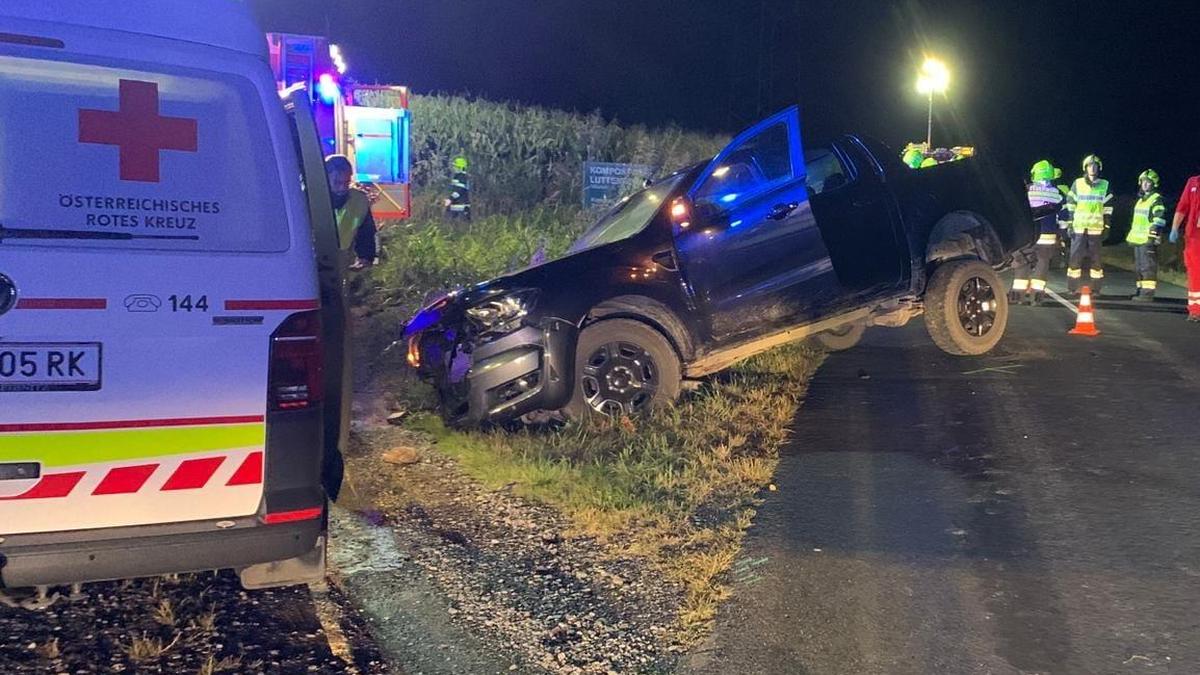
[689,265,1200,675]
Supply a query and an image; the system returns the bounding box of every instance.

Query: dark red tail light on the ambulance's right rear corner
[268,311,324,411]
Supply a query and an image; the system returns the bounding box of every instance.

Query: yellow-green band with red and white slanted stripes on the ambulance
[0,414,266,531]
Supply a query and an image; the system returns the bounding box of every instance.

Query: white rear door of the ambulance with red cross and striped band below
[0,17,323,536]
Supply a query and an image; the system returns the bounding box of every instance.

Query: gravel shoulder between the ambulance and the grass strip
[331,423,683,673]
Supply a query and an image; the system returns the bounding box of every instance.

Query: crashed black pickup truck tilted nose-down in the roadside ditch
[404,107,1036,425]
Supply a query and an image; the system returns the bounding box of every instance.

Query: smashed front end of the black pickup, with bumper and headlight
[404,287,576,426]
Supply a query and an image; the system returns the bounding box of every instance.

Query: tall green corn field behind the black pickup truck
[409,95,727,214]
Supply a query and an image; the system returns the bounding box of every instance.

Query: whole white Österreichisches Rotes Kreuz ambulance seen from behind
[0,0,348,587]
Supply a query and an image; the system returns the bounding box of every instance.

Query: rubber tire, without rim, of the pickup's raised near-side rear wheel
[925,259,1008,357]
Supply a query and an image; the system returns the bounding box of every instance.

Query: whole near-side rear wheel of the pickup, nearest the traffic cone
[925,259,1008,357]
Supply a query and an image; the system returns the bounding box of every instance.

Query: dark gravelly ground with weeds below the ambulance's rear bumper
[0,572,389,675]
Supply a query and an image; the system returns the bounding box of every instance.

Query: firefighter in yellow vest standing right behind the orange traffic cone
[1067,155,1112,297]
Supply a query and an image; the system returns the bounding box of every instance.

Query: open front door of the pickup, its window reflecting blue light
[676,106,835,342]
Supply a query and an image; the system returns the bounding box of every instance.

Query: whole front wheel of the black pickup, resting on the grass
[563,318,683,419]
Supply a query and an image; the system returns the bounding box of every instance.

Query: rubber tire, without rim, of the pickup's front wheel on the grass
[562,318,683,419]
